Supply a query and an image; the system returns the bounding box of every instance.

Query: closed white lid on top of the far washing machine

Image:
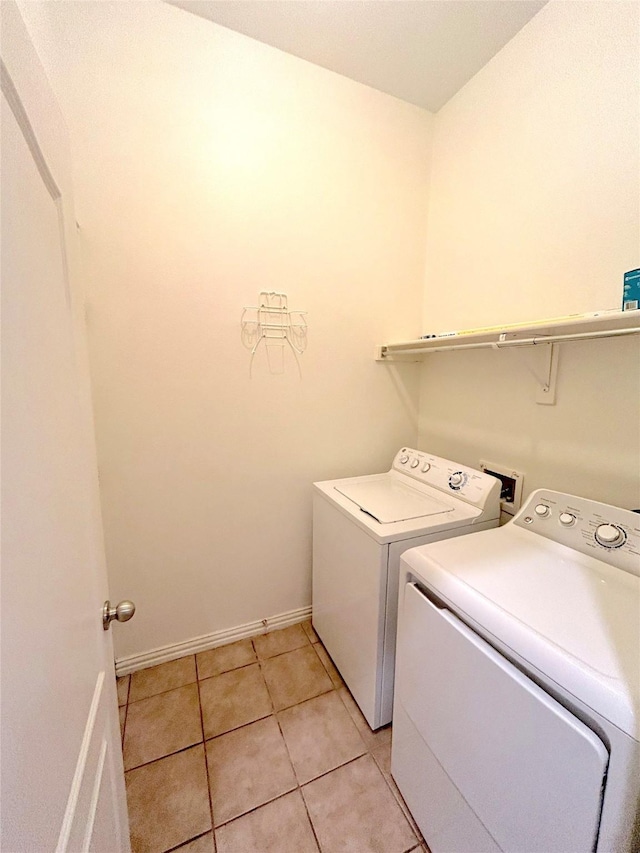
[334,476,453,524]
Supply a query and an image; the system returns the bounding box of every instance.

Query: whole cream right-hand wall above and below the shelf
[420,2,640,507]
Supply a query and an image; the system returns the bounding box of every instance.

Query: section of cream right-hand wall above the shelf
[423,0,640,333]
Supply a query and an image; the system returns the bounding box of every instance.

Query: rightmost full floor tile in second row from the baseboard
[261,643,333,711]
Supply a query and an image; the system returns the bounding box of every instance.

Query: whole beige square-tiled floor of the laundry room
[118,622,427,853]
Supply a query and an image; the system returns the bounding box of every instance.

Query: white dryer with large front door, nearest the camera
[391,490,640,853]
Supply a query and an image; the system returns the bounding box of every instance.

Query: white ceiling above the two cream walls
[167,0,546,112]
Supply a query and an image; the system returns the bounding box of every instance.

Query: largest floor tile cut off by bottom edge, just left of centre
[215,791,318,853]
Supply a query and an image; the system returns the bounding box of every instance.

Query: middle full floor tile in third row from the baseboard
[206,717,297,826]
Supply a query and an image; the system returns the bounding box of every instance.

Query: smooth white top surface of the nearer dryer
[402,524,640,741]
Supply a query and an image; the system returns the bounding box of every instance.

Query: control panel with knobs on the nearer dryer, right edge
[511,489,640,576]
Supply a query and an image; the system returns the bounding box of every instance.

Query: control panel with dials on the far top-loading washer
[392,447,502,518]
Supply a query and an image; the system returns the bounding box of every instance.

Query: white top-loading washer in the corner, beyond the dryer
[313,447,501,729]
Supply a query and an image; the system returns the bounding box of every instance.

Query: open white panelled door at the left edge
[0,0,130,853]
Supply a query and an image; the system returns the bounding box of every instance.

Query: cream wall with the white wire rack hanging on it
[24,3,432,656]
